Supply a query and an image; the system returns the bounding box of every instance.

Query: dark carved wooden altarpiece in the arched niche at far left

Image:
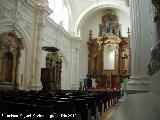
[0,31,23,89]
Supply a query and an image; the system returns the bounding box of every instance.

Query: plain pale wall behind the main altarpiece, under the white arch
[80,8,130,79]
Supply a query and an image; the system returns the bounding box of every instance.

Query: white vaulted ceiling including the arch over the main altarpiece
[64,0,129,33]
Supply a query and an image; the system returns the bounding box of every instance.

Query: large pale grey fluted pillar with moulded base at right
[127,0,154,93]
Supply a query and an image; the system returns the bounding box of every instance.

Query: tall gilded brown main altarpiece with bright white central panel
[87,10,131,89]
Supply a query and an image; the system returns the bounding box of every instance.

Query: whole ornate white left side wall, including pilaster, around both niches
[0,0,79,90]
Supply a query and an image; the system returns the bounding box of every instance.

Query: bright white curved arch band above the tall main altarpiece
[74,0,130,37]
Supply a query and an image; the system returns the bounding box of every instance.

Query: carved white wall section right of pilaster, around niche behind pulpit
[41,18,79,90]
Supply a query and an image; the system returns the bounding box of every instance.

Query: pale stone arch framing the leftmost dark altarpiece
[0,20,31,89]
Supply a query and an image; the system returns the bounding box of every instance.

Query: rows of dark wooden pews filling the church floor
[0,90,120,120]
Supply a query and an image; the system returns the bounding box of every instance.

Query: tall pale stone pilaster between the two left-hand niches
[28,6,50,90]
